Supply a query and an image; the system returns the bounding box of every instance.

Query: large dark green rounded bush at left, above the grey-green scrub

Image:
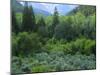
[12,32,41,55]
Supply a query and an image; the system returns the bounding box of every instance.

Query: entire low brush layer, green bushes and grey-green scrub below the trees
[12,32,96,73]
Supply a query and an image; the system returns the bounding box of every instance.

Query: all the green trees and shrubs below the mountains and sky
[11,3,96,73]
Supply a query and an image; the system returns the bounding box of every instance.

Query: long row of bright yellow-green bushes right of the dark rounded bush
[44,38,96,55]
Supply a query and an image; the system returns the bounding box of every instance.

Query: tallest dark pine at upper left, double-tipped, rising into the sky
[22,2,35,32]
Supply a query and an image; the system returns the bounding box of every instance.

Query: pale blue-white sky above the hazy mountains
[20,2,78,14]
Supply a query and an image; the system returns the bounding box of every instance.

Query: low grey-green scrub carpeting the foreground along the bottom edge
[12,52,96,73]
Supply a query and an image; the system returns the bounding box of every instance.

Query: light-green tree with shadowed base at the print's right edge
[83,15,96,40]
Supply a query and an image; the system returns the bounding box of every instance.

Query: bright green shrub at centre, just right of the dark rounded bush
[44,39,71,53]
